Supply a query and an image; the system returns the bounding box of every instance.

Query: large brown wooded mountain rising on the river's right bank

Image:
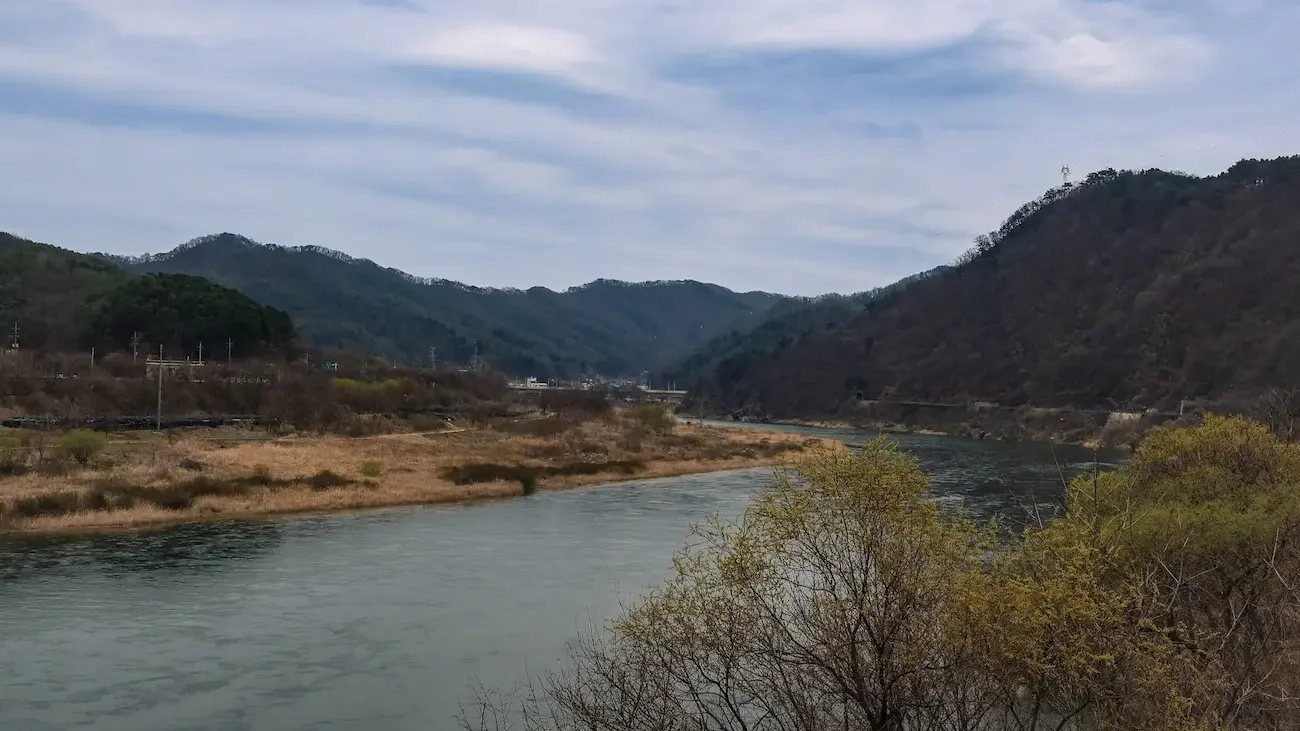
[693,157,1300,416]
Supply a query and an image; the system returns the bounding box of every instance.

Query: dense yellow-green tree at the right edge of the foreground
[1044,416,1300,728]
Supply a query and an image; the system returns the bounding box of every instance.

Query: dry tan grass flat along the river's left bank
[0,419,820,532]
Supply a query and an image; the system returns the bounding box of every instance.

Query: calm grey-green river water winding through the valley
[0,428,1118,731]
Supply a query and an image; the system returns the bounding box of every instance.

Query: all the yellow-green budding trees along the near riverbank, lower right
[462,416,1300,731]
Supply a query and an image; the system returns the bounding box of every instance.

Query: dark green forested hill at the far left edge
[0,233,294,355]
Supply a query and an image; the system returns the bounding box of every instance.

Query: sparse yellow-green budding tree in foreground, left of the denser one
[467,441,996,730]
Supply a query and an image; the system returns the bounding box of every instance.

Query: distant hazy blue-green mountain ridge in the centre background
[114,233,781,377]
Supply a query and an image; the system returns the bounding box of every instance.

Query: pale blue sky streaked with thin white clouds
[0,0,1300,295]
